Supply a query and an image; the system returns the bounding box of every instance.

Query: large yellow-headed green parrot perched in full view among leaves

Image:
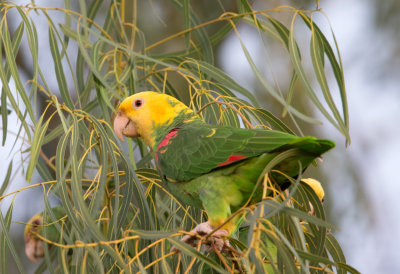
[113,91,335,251]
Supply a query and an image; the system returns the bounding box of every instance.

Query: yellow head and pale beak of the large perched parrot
[114,91,195,147]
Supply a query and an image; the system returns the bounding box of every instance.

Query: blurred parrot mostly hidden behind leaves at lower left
[24,206,66,262]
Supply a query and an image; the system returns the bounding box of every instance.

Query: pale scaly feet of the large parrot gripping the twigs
[171,222,231,252]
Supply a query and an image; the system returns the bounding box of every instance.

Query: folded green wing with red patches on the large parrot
[155,124,334,181]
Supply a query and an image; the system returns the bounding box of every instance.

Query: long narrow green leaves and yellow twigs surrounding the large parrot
[0,0,356,273]
